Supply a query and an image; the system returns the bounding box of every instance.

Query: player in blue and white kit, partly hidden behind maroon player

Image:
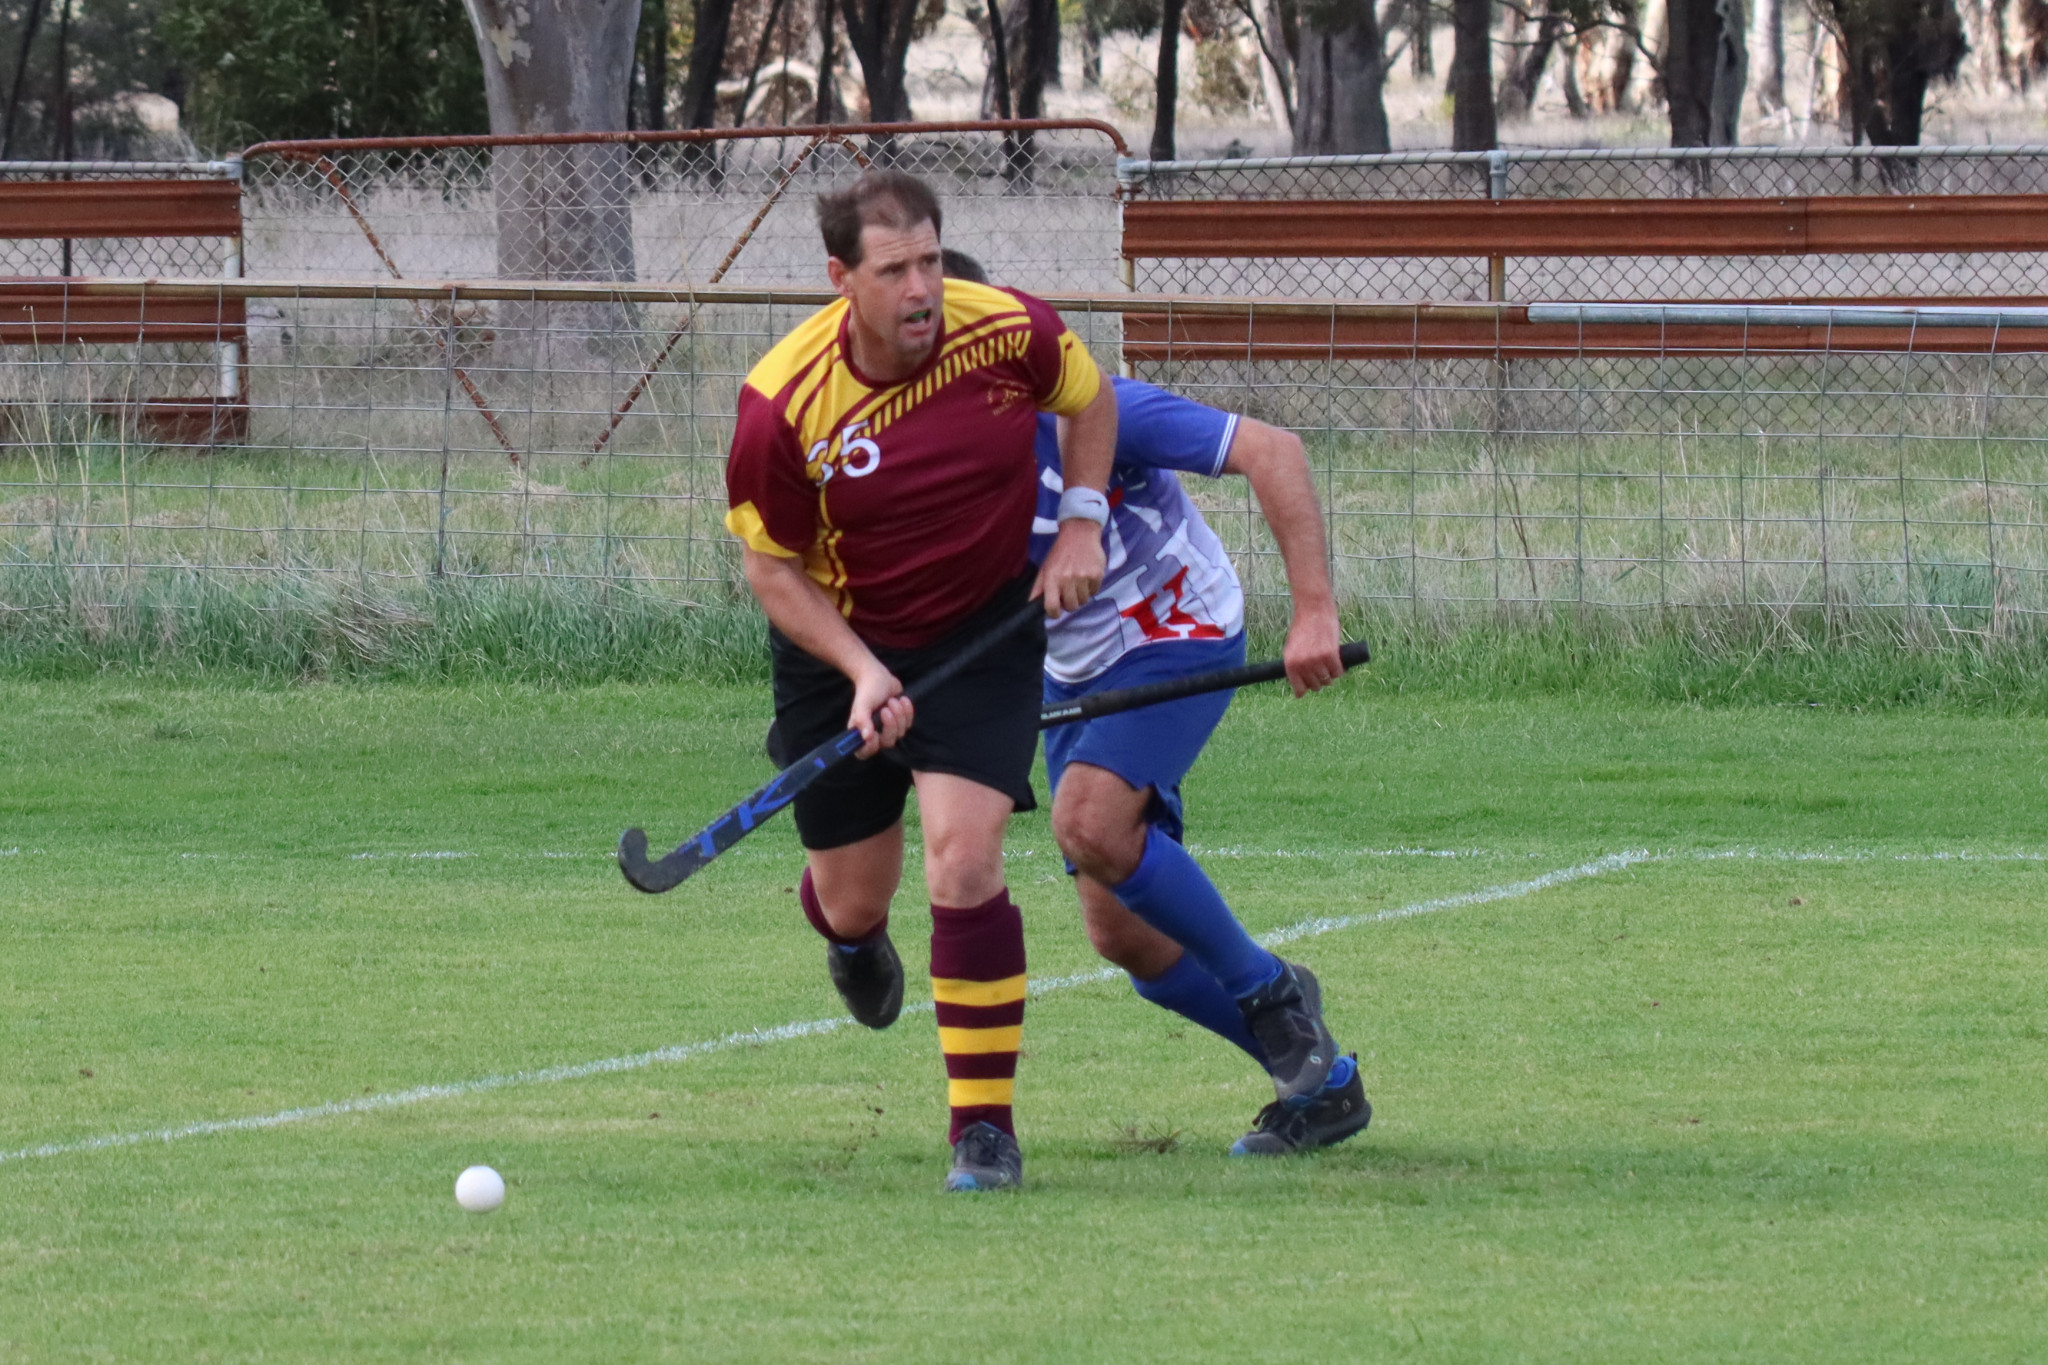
[1032,379,1372,1154]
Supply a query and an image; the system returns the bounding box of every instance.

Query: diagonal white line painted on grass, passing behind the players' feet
[0,849,1659,1164]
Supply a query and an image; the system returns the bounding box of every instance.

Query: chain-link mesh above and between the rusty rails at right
[1118,145,2048,301]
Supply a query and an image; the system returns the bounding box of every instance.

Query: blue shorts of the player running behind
[1044,632,1245,839]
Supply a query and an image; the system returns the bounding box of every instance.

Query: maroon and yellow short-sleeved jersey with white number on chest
[725,280,1102,649]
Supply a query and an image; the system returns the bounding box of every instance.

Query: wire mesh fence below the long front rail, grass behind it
[0,282,2048,632]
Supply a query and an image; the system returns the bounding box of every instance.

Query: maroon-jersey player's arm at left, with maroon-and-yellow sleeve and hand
[725,381,913,757]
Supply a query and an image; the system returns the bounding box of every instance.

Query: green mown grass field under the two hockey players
[0,681,2048,1363]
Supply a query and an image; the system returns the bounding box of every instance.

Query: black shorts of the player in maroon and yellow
[768,573,1044,849]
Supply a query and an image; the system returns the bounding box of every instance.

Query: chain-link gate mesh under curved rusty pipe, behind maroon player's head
[244,121,1122,293]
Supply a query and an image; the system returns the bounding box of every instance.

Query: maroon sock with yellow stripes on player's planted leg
[932,888,1024,1142]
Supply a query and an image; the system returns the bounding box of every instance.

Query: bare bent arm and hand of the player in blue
[1223,417,1343,696]
